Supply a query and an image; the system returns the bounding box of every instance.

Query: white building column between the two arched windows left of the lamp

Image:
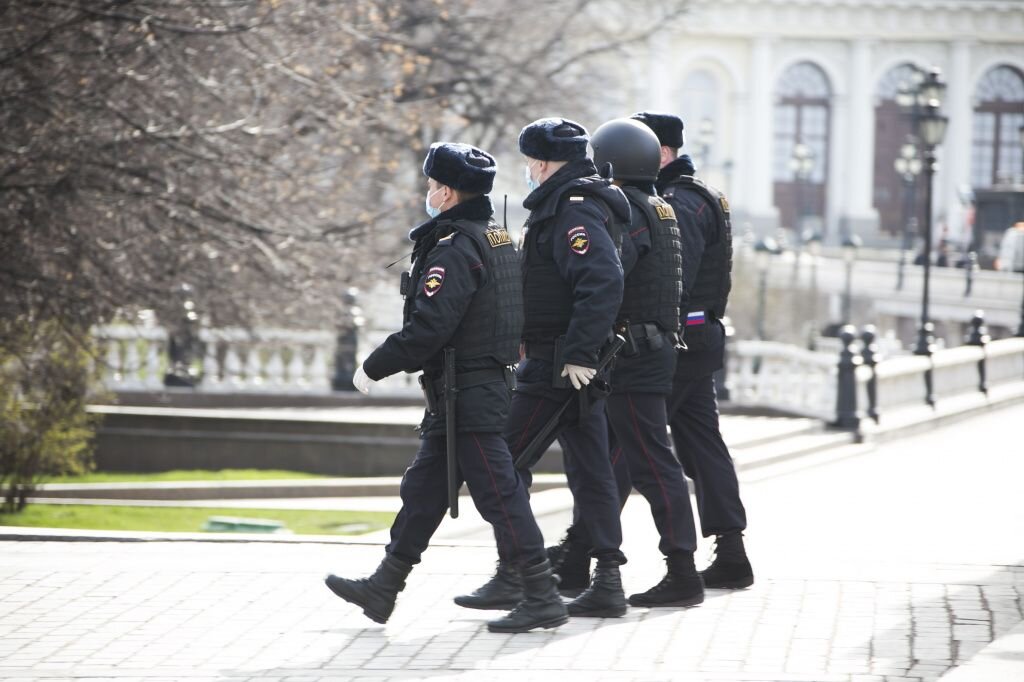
[829,40,880,244]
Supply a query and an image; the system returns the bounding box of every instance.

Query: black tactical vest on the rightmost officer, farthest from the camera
[662,175,732,319]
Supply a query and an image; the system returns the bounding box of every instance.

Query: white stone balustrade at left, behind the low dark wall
[93,325,335,393]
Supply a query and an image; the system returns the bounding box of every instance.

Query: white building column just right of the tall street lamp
[933,41,974,244]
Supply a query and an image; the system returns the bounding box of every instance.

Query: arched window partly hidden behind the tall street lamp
[872,63,925,239]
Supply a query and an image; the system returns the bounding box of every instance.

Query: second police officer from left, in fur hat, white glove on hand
[457,118,630,617]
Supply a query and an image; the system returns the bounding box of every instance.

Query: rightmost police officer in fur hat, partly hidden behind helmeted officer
[632,112,754,589]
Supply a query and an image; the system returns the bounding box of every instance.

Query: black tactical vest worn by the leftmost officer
[406,220,523,365]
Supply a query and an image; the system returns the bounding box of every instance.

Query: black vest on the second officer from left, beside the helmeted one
[522,185,623,343]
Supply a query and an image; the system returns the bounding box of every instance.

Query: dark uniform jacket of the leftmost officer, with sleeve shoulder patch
[362,197,510,436]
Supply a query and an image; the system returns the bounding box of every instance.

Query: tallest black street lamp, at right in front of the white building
[904,69,949,407]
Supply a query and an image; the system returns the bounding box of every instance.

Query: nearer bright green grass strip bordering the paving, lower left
[0,504,394,536]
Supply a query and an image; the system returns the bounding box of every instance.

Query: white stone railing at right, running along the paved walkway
[726,338,1024,422]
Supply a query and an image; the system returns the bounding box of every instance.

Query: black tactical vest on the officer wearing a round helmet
[618,186,683,333]
